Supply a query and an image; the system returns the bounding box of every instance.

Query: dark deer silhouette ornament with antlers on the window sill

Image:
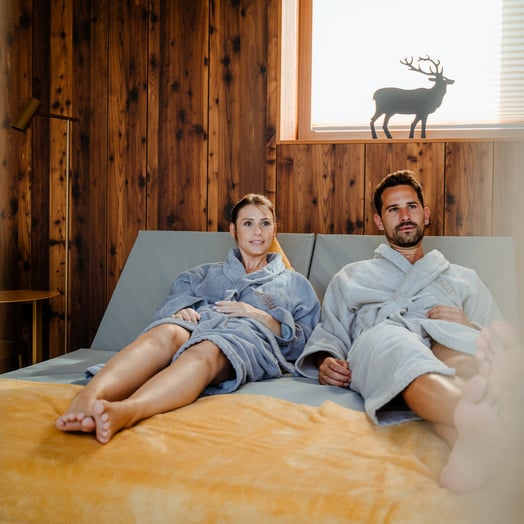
[370,56,455,138]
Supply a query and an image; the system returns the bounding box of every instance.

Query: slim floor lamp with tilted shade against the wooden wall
[11,98,80,353]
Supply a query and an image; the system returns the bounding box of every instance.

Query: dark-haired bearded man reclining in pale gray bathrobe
[296,171,501,490]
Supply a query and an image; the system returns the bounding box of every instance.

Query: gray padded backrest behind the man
[309,235,518,325]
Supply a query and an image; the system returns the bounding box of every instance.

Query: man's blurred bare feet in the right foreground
[440,322,524,492]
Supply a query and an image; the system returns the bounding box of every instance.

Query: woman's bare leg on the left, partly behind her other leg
[56,324,189,432]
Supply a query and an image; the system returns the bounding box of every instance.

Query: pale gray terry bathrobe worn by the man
[296,244,501,424]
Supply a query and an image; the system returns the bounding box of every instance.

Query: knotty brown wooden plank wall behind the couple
[0,0,523,368]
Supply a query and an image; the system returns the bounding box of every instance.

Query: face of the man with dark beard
[374,186,430,247]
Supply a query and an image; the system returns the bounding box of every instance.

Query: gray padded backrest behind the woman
[91,231,315,351]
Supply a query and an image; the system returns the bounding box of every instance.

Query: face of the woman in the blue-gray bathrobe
[229,204,277,256]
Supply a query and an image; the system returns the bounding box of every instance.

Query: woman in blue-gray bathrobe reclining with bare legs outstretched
[56,194,320,443]
